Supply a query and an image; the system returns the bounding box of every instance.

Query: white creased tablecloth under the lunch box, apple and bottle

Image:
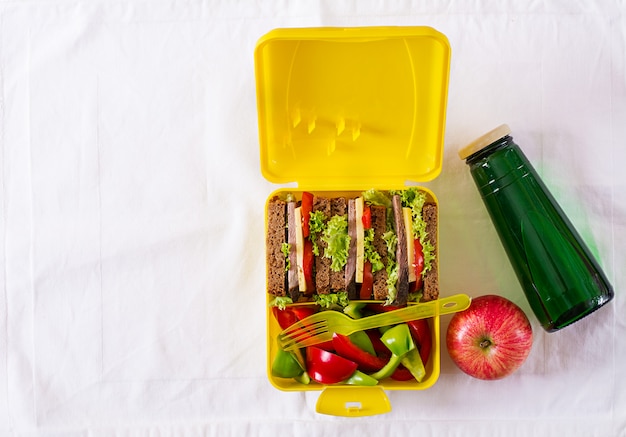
[0,0,626,436]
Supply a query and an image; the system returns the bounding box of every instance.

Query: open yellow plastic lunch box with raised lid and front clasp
[255,27,450,417]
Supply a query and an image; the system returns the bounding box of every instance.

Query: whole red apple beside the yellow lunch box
[446,295,533,380]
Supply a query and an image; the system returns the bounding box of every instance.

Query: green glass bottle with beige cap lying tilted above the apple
[459,125,614,332]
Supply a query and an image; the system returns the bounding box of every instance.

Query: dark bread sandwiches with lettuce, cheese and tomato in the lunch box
[266,187,439,306]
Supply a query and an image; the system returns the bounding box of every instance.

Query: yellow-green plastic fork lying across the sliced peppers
[278,294,472,351]
